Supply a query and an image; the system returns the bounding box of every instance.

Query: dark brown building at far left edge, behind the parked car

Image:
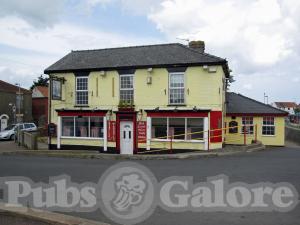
[0,80,32,130]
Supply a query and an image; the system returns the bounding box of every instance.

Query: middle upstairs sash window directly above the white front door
[120,74,133,104]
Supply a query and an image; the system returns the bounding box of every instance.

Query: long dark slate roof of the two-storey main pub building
[44,43,229,75]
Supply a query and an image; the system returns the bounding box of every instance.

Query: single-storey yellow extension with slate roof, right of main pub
[225,92,287,146]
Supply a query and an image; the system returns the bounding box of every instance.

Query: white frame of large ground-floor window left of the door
[60,116,106,140]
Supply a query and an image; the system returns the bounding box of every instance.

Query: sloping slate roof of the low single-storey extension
[226,92,288,115]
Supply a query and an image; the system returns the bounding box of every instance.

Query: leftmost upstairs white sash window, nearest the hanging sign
[76,77,89,105]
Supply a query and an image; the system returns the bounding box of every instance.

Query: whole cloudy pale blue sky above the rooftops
[0,0,300,103]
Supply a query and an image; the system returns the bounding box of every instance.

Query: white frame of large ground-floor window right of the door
[150,117,207,143]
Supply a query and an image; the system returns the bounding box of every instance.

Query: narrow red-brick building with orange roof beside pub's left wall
[32,86,48,127]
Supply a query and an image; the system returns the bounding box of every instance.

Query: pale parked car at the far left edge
[0,123,37,140]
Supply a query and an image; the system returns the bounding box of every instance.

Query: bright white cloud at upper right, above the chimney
[148,0,299,66]
